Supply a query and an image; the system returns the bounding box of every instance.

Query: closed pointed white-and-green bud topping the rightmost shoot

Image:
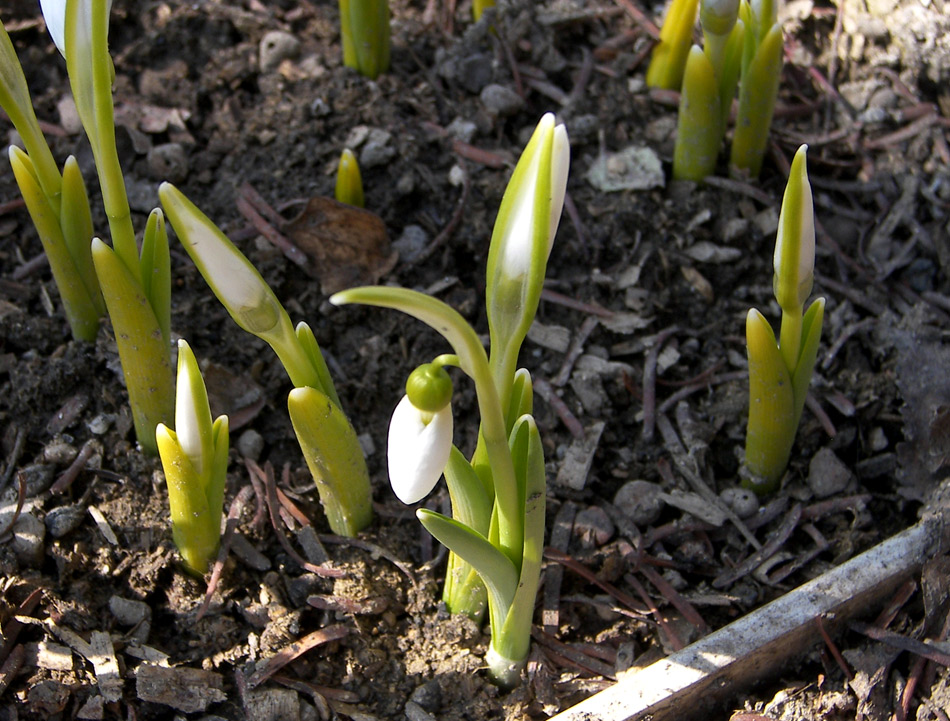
[772,145,815,310]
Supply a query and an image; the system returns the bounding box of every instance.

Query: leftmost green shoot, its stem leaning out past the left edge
[0,23,106,341]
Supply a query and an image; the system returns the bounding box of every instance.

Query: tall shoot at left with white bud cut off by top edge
[43,0,174,455]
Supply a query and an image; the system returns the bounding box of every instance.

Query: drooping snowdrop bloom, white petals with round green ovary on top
[388,363,453,505]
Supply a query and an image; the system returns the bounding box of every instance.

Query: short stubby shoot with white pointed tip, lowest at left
[155,340,228,575]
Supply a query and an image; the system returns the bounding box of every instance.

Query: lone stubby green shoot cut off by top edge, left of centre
[340,0,389,80]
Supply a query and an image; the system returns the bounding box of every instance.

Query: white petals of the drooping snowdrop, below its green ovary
[388,396,453,504]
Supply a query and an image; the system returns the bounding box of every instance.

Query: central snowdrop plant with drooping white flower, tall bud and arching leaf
[330,115,570,686]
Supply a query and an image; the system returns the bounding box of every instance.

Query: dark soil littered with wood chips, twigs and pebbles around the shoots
[0,0,950,721]
